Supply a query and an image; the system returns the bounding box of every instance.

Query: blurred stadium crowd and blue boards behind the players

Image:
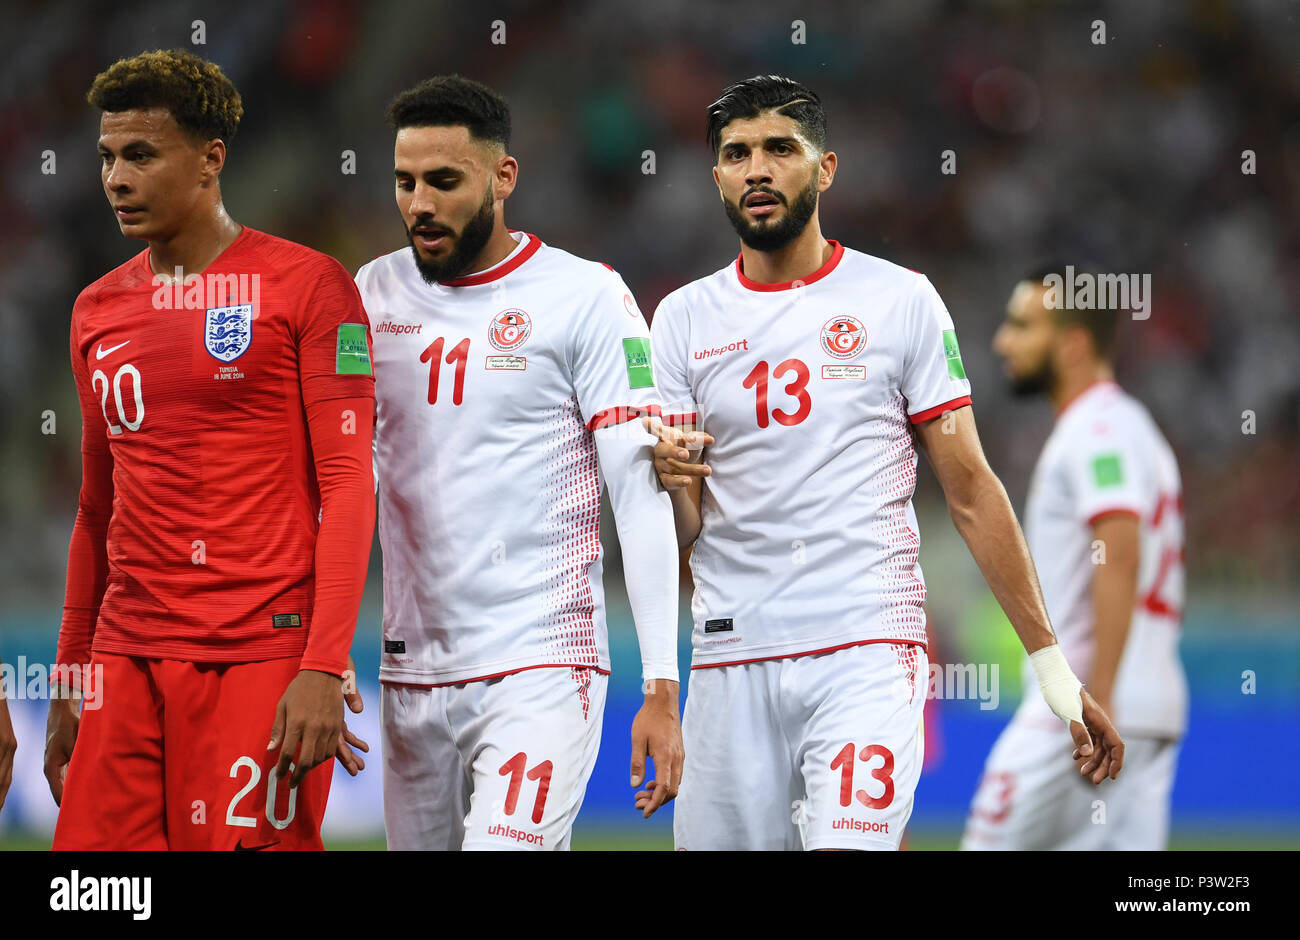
[0,0,1300,848]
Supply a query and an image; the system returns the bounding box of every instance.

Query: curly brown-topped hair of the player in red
[86,49,243,144]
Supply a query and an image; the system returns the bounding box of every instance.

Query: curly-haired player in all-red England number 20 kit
[46,51,374,849]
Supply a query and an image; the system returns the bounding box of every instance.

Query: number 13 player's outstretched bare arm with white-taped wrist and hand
[917,406,1123,784]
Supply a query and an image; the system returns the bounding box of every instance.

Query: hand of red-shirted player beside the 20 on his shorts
[267,670,343,788]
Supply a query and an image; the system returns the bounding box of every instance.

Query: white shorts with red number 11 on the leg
[380,666,608,850]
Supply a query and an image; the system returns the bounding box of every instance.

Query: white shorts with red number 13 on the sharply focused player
[673,642,930,850]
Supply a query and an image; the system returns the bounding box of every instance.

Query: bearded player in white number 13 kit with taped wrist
[637,75,1123,849]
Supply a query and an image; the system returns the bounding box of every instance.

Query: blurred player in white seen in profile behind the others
[962,268,1187,849]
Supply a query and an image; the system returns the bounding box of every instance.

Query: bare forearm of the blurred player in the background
[1088,512,1140,714]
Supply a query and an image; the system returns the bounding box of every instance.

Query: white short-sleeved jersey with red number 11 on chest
[356,233,659,685]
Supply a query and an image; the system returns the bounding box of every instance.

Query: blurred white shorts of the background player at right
[962,711,1179,850]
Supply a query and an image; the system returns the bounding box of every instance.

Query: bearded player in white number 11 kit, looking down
[356,75,683,849]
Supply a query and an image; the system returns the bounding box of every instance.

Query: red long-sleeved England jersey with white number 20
[59,226,374,671]
